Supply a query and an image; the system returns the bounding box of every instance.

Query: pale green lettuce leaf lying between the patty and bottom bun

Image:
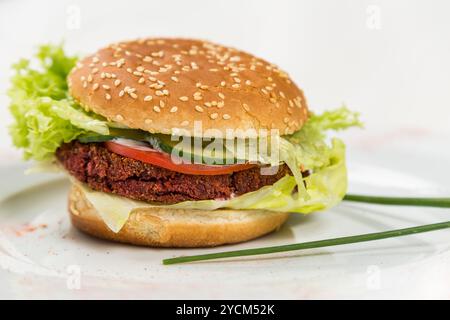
[78,139,347,232]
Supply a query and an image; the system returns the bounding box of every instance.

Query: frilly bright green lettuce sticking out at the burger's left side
[8,45,109,161]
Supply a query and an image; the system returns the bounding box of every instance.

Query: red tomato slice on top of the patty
[105,141,256,176]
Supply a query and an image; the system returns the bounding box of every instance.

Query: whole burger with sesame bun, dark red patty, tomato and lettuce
[9,38,360,247]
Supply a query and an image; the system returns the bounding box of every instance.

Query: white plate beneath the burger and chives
[0,132,450,299]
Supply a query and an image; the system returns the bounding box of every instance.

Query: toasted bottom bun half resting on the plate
[69,185,289,248]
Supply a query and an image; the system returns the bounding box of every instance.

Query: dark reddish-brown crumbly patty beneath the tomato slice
[56,142,290,204]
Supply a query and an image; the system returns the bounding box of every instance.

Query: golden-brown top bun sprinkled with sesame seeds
[68,39,308,136]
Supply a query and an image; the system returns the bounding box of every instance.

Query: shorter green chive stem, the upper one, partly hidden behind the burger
[344,194,450,208]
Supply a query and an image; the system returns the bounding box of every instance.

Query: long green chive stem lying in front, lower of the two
[163,221,450,265]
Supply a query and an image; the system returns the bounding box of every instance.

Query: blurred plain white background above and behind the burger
[0,0,450,158]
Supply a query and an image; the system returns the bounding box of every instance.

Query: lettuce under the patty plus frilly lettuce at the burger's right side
[75,107,362,232]
